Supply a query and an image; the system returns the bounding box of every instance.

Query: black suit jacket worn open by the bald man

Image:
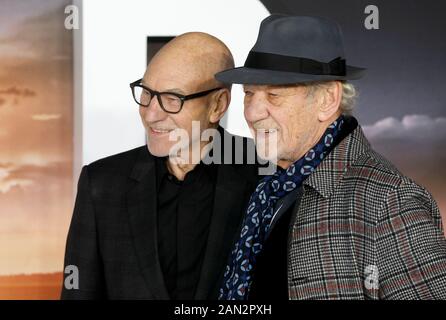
[61,129,258,300]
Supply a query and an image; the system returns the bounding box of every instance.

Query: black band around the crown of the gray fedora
[245,51,346,76]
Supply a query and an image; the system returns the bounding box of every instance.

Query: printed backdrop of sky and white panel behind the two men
[0,0,446,299]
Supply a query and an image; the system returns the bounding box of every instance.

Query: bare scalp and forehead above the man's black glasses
[144,32,234,90]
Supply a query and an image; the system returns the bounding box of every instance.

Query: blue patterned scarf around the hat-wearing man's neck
[219,115,344,300]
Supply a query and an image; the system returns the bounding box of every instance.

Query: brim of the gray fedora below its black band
[215,66,366,85]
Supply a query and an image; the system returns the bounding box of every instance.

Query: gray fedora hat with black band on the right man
[215,14,365,85]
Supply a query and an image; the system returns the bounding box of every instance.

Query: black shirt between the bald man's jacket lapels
[156,158,216,300]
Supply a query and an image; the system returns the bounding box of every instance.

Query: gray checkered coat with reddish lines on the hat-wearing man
[288,126,446,299]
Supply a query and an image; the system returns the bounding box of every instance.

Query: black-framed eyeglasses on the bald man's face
[130,79,222,113]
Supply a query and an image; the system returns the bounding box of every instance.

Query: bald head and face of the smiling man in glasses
[139,32,234,157]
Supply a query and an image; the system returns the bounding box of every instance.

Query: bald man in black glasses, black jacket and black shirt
[62,33,257,300]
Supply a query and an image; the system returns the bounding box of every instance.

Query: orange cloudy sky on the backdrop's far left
[0,0,73,275]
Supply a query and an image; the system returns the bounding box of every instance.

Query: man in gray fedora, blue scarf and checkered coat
[216,15,446,300]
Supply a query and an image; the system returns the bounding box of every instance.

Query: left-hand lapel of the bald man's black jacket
[126,146,169,300]
